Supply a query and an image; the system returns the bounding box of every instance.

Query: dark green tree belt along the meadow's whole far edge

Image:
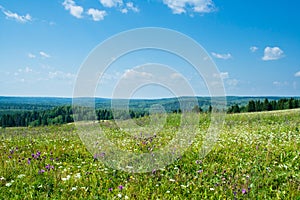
[0,98,300,128]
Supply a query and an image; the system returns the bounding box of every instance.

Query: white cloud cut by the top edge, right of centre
[163,0,215,14]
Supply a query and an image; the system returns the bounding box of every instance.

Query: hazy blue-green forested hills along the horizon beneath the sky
[0,96,300,115]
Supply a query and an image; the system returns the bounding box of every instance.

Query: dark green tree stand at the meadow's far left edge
[0,106,149,128]
